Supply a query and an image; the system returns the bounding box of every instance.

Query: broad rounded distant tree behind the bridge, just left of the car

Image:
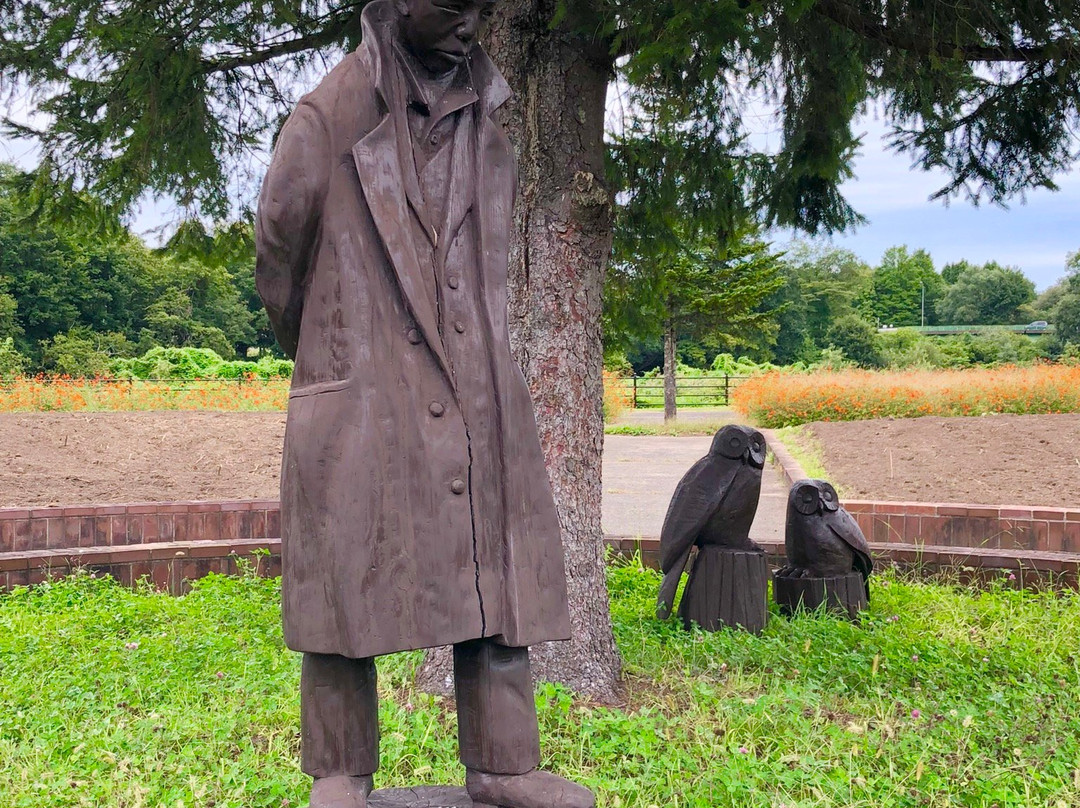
[934,261,1035,325]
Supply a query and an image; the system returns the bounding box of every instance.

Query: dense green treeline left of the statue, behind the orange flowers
[0,165,276,376]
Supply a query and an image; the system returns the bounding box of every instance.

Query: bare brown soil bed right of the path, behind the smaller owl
[810,415,1080,508]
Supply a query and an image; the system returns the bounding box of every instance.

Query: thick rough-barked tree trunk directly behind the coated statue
[421,0,621,701]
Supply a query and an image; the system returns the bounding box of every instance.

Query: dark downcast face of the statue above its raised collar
[396,0,495,76]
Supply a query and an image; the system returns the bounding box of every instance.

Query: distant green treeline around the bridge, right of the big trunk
[608,243,1080,373]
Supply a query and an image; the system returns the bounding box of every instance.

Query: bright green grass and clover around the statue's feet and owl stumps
[0,565,1080,808]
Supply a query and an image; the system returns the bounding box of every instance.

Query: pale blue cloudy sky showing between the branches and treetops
[6,96,1080,292]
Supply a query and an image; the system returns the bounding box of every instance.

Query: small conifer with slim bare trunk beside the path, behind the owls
[605,223,783,421]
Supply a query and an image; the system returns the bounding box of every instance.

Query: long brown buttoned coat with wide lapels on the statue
[256,2,569,658]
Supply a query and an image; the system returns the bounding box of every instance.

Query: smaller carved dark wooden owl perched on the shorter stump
[777,480,874,598]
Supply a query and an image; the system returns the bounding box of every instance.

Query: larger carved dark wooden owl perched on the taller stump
[657,425,765,620]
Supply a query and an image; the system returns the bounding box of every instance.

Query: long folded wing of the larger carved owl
[657,456,740,620]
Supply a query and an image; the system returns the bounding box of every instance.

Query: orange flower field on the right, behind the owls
[731,364,1080,427]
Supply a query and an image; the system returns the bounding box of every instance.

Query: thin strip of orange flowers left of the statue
[0,376,289,413]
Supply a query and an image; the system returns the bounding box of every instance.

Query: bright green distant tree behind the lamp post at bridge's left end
[866,246,945,326]
